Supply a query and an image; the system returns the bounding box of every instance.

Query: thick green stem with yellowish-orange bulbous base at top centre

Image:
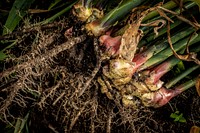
[86,0,144,36]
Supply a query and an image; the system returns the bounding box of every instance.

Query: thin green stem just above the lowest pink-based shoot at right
[165,65,200,89]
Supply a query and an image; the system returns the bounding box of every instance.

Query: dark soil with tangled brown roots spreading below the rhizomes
[0,15,200,133]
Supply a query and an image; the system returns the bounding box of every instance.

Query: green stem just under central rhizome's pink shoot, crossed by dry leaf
[139,31,200,71]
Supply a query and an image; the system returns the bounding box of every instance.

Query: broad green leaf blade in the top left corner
[3,0,34,35]
